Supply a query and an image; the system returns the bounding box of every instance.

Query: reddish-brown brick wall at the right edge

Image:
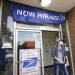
[67,8,75,72]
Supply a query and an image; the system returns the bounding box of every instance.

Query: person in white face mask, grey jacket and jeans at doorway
[51,39,69,75]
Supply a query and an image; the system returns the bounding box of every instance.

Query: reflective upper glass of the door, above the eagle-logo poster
[18,31,41,49]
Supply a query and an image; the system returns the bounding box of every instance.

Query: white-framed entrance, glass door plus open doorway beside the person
[13,24,60,75]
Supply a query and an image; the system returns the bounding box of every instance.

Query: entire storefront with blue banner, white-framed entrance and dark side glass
[0,0,73,75]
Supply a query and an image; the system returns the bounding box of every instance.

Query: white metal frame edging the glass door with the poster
[13,22,44,75]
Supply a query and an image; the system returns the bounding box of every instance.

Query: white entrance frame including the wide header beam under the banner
[13,22,61,75]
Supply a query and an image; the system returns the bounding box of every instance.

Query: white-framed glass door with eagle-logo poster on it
[15,29,43,75]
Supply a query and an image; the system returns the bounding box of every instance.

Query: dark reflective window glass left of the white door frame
[0,0,14,75]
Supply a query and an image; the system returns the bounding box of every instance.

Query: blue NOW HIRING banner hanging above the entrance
[9,1,66,24]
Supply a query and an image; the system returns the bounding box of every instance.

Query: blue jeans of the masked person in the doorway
[54,64,69,75]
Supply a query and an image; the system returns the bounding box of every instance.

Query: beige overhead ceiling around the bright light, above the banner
[10,0,75,12]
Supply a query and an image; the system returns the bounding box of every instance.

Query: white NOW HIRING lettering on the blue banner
[17,9,62,20]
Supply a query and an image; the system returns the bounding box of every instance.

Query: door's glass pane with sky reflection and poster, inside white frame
[17,30,42,75]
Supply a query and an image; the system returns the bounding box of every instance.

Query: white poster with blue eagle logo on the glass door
[19,49,41,75]
